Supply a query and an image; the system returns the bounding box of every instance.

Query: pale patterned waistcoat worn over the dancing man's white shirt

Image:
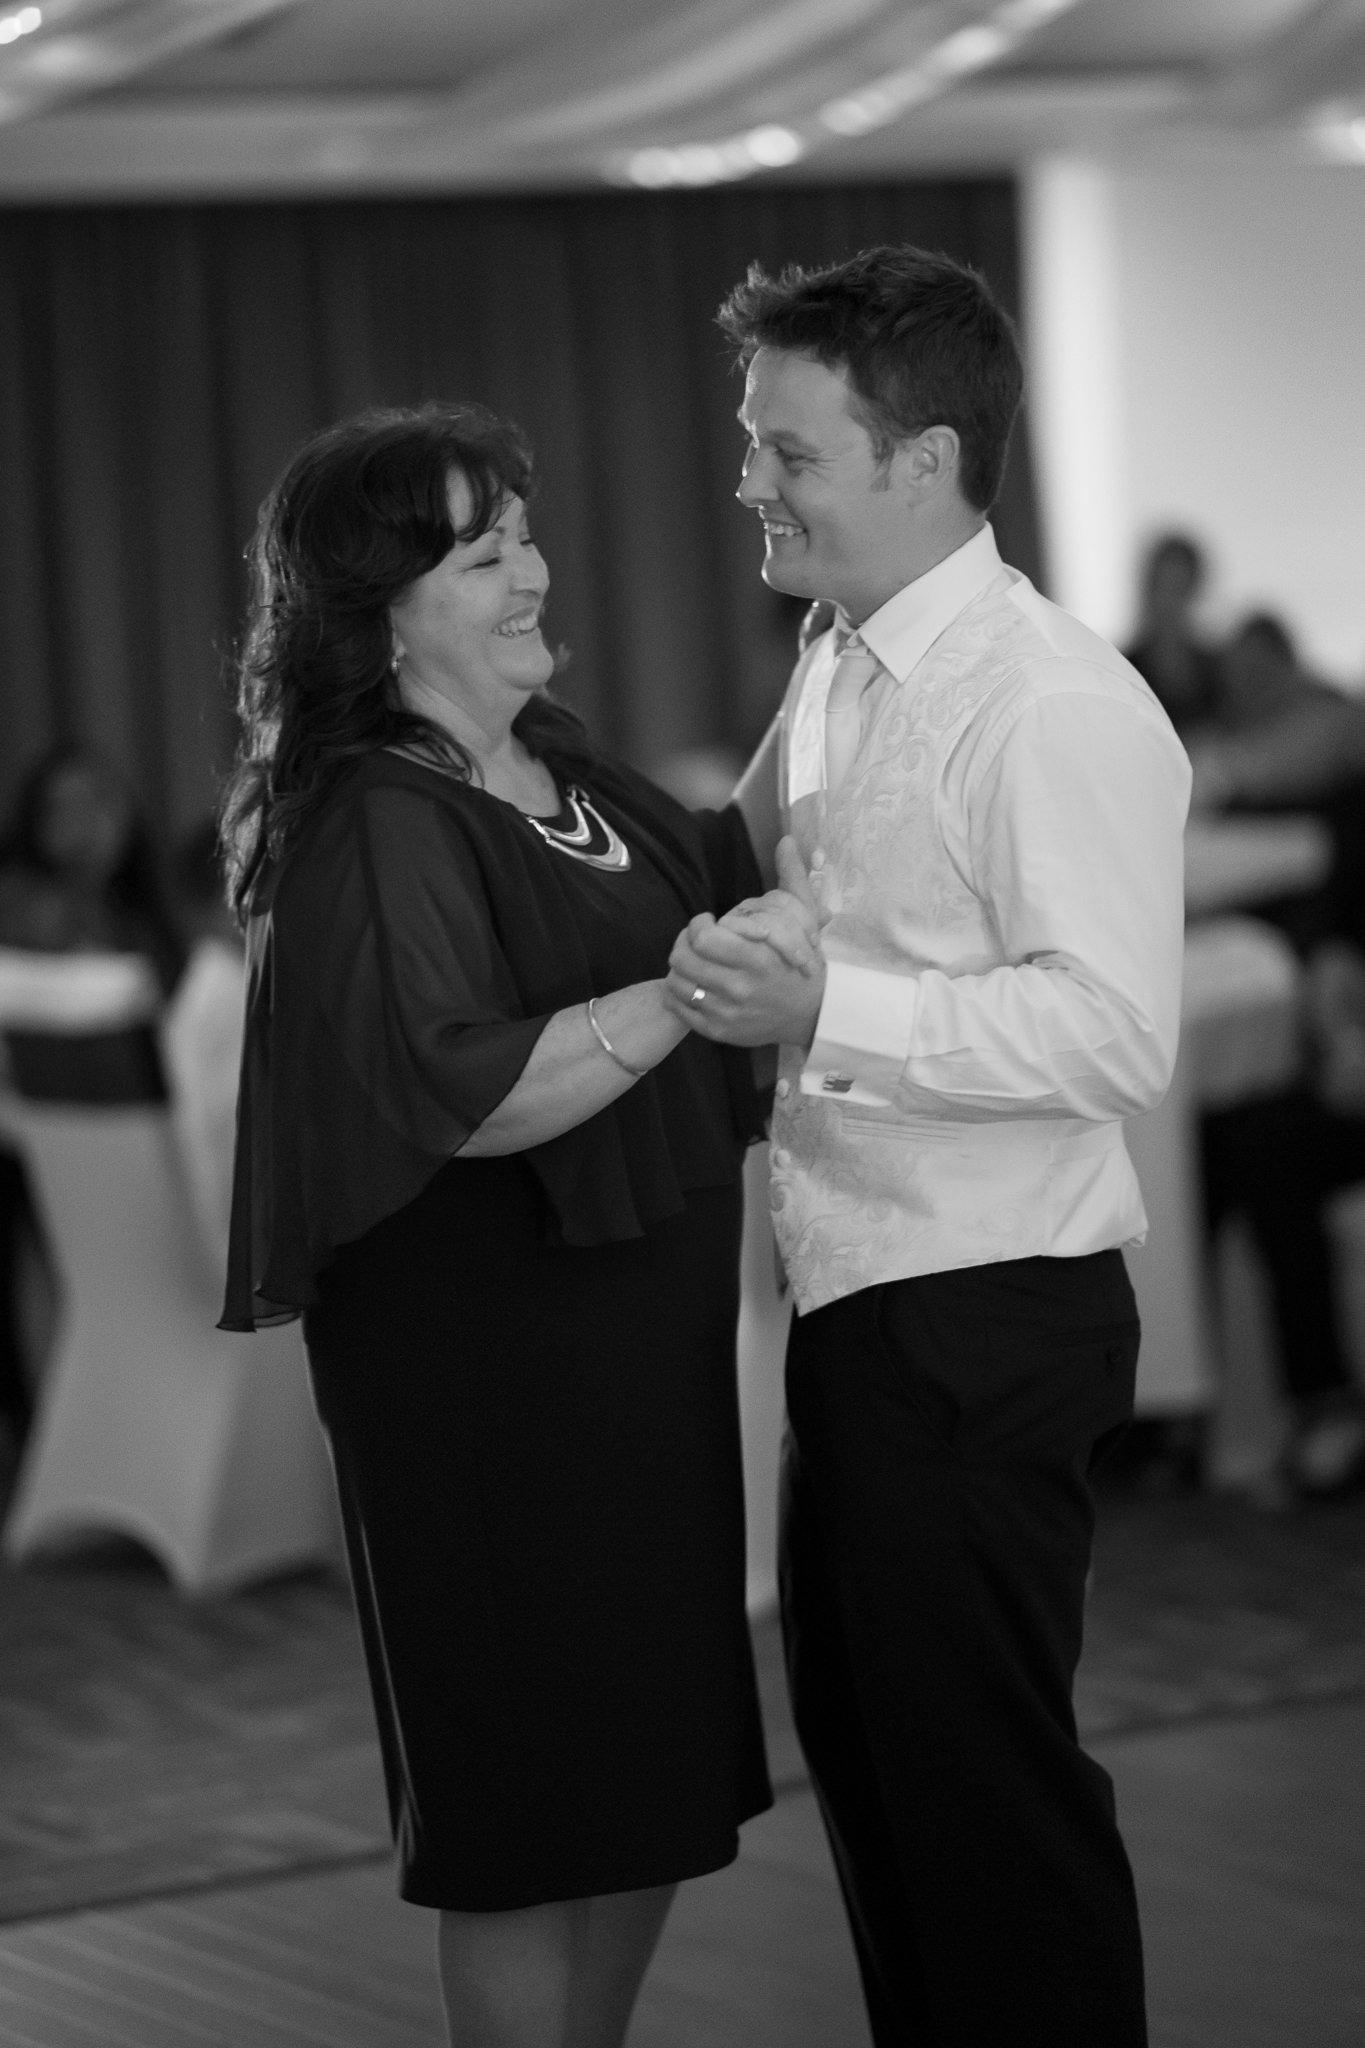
[772,569,1146,1311]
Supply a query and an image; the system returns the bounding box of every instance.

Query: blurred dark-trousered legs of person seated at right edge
[1199,940,1365,1499]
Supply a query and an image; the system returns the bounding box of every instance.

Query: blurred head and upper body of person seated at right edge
[1189,612,1365,954]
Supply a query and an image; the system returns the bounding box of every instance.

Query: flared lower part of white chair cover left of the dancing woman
[0,1098,340,1593]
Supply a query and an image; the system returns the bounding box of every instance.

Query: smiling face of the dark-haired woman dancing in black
[391,471,555,715]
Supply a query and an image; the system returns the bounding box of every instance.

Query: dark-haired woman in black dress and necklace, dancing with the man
[225,406,772,2048]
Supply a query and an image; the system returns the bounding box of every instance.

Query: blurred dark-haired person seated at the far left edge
[0,743,184,1102]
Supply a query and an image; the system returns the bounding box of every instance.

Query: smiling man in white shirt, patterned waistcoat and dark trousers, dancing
[669,248,1189,2048]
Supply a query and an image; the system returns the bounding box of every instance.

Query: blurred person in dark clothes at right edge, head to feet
[1187,610,1365,1499]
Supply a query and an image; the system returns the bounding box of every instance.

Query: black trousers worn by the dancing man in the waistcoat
[782,1251,1146,2048]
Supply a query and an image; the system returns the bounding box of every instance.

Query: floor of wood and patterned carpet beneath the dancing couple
[0,1499,1365,2048]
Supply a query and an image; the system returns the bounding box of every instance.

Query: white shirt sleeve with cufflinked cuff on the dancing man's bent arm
[802,657,1189,1122]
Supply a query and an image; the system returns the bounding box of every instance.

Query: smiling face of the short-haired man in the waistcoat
[737,348,913,625]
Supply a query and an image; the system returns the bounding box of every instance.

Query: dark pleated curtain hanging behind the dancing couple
[0,180,1040,831]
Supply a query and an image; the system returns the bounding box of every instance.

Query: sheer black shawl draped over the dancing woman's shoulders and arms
[223,754,761,1329]
